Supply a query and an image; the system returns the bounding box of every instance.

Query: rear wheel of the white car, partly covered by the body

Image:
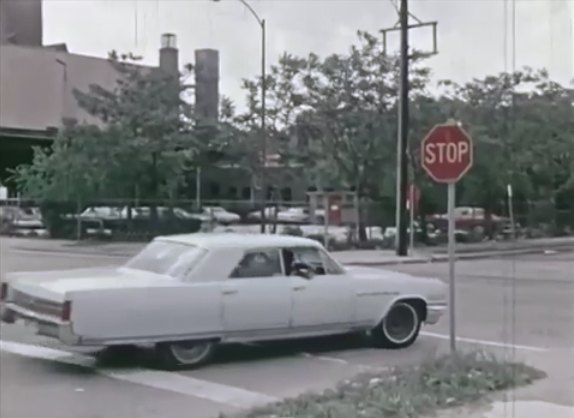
[156,341,216,370]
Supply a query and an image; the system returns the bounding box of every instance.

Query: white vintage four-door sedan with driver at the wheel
[0,233,447,368]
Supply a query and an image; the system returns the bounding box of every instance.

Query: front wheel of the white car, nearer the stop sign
[371,301,422,348]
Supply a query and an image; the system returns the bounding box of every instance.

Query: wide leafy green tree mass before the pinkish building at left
[14,52,201,219]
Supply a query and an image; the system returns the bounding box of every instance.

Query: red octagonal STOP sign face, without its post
[421,124,473,183]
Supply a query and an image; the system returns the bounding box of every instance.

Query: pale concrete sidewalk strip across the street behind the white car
[0,237,574,266]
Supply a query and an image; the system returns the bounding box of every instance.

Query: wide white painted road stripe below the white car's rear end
[0,340,279,408]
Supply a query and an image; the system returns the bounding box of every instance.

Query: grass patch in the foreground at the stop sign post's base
[220,352,546,418]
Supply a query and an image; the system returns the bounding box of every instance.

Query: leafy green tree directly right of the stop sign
[436,68,574,233]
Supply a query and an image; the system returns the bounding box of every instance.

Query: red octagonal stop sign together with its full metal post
[421,121,474,353]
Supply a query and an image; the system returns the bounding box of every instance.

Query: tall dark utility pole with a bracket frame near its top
[381,0,438,256]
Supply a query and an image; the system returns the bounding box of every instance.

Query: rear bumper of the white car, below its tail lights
[0,302,81,345]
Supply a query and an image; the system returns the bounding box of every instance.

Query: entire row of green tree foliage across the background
[10,32,574,233]
